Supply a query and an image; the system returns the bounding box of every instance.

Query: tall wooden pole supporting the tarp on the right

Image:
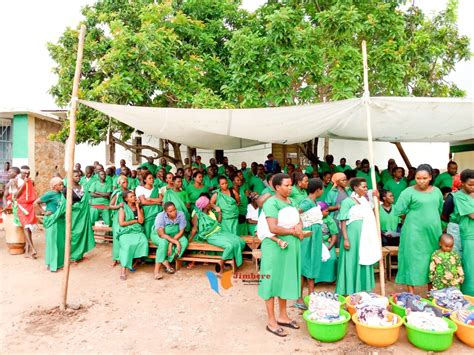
[362,40,385,296]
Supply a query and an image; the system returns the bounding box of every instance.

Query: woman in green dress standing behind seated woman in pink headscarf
[211,176,240,235]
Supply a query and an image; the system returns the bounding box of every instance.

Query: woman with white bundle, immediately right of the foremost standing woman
[295,179,323,309]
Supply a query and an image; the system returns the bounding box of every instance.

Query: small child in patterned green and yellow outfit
[430,233,464,290]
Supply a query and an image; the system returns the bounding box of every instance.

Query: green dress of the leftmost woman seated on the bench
[117,204,148,269]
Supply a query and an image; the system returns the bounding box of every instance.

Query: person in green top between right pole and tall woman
[380,190,400,246]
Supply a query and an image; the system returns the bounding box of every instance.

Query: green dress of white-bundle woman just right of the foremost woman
[298,198,323,281]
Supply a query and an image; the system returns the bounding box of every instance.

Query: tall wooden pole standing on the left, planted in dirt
[59,25,86,311]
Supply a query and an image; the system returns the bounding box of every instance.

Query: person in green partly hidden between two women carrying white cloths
[317,202,339,282]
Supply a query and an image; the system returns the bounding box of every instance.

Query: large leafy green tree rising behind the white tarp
[49,0,470,162]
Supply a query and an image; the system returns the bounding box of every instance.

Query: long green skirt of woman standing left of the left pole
[44,218,66,271]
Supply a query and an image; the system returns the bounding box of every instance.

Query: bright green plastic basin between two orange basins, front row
[403,317,458,351]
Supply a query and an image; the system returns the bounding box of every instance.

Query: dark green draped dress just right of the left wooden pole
[71,191,95,261]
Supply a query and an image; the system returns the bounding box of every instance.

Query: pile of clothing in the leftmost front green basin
[308,292,344,323]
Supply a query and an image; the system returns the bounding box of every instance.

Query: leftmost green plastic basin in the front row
[303,309,351,343]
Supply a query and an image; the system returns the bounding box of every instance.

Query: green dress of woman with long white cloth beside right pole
[336,198,375,295]
